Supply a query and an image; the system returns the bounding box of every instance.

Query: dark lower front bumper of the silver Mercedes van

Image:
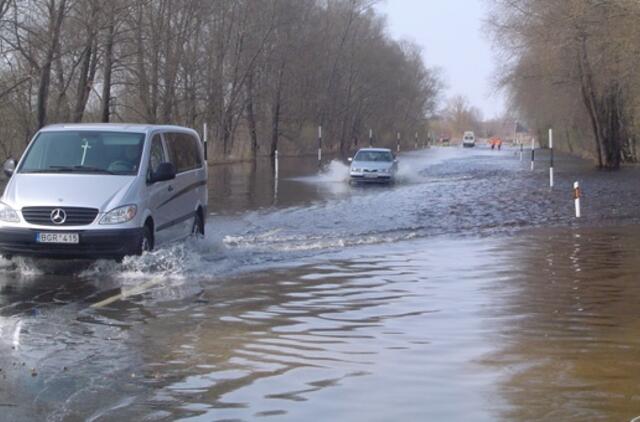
[0,227,143,259]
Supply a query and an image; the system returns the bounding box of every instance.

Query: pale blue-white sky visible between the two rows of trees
[376,0,505,118]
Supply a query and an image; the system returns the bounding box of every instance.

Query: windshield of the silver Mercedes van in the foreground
[18,130,145,175]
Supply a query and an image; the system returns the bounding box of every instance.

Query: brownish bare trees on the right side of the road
[489,0,640,168]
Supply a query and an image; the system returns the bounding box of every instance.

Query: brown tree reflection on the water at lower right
[486,226,640,421]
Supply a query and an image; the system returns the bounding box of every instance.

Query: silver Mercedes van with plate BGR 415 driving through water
[0,124,208,259]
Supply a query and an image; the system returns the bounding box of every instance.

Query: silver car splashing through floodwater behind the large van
[349,148,398,183]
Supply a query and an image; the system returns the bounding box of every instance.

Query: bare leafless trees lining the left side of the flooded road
[0,0,440,160]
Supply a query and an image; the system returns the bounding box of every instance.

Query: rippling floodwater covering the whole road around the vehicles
[0,148,640,421]
